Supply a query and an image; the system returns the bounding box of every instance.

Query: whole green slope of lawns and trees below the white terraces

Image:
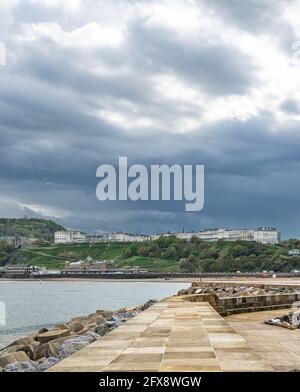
[5,236,300,272]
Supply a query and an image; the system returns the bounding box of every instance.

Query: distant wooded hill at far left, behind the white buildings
[0,218,65,241]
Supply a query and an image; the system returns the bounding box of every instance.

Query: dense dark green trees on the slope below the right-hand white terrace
[120,236,300,272]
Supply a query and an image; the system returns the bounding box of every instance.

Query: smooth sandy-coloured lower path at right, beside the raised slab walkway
[225,309,300,371]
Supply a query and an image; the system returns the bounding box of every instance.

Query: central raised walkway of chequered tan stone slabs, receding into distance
[49,301,275,372]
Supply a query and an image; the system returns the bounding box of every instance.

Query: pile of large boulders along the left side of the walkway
[0,299,158,372]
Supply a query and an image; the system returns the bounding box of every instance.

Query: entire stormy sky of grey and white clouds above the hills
[0,0,300,238]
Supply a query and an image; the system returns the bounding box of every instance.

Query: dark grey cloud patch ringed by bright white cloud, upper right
[130,21,255,95]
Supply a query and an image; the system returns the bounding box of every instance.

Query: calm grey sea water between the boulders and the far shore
[0,279,189,349]
